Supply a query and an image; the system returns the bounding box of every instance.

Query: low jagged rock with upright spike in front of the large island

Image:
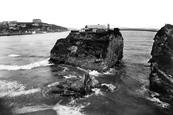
[49,73,101,98]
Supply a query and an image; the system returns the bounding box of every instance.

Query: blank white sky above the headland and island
[0,0,173,28]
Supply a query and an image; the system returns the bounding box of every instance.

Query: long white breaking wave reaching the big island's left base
[0,59,51,70]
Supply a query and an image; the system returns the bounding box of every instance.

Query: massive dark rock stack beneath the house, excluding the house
[50,29,123,71]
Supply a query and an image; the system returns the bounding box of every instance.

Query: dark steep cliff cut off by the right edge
[149,24,173,105]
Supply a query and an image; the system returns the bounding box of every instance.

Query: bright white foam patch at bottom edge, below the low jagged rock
[53,103,85,115]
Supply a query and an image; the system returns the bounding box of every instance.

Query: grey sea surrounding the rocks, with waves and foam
[0,31,173,115]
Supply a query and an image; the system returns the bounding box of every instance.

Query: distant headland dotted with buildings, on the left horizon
[0,19,68,36]
